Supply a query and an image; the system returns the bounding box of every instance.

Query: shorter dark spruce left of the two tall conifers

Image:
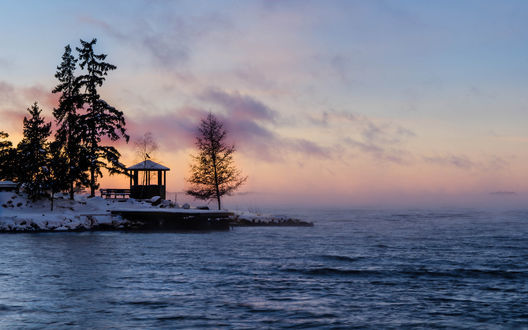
[17,102,51,200]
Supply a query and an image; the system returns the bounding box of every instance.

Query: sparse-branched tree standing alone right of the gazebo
[186,113,247,210]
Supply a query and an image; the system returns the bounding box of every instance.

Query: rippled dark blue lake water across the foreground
[0,210,528,328]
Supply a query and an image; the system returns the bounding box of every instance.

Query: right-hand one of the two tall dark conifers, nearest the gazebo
[76,39,129,196]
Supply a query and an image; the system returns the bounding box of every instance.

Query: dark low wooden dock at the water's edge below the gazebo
[110,209,233,231]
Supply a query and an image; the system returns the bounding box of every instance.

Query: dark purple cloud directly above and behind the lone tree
[129,88,334,162]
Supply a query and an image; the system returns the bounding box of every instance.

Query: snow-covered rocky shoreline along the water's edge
[0,192,313,233]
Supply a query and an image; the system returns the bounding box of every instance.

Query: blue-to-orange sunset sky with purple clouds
[0,0,528,207]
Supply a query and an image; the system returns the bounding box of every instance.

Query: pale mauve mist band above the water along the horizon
[178,190,528,213]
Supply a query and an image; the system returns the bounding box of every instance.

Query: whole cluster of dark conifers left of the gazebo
[0,39,129,209]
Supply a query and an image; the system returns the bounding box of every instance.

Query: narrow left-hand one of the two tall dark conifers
[52,45,89,199]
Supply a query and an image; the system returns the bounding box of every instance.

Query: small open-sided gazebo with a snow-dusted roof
[126,159,170,199]
